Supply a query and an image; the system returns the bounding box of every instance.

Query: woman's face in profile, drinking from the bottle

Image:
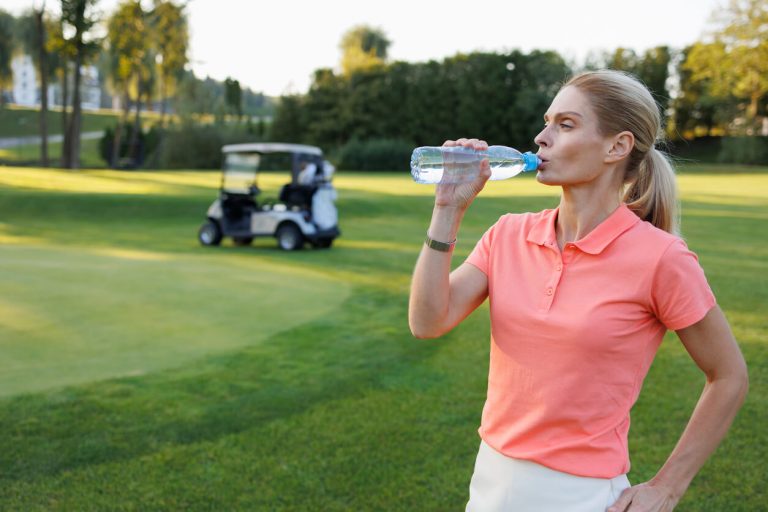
[534,86,612,185]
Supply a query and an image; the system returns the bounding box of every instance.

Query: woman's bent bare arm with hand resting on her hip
[608,306,748,512]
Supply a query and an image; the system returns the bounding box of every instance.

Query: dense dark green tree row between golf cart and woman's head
[272,47,569,150]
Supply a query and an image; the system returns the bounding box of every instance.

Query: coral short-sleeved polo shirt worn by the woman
[467,205,715,478]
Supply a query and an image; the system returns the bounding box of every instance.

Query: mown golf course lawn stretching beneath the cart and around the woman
[0,167,768,511]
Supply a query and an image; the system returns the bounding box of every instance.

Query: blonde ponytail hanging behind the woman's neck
[623,147,680,235]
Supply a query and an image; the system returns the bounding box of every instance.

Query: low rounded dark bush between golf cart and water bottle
[338,139,413,171]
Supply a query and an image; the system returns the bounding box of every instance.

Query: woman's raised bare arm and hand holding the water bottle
[408,139,490,338]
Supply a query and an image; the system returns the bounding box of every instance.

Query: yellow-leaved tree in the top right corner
[684,0,768,134]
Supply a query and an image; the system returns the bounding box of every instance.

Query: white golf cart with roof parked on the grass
[198,142,341,251]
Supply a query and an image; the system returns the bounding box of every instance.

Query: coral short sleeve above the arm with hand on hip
[651,239,716,331]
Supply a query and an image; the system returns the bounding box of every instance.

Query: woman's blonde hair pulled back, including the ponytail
[563,70,680,234]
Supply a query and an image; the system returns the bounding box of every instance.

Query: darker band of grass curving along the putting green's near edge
[0,289,450,488]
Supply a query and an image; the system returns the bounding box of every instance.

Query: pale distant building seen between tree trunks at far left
[11,55,101,110]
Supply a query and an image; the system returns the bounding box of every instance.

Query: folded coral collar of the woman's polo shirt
[527,203,640,254]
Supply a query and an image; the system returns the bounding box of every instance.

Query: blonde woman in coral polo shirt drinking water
[409,71,747,512]
